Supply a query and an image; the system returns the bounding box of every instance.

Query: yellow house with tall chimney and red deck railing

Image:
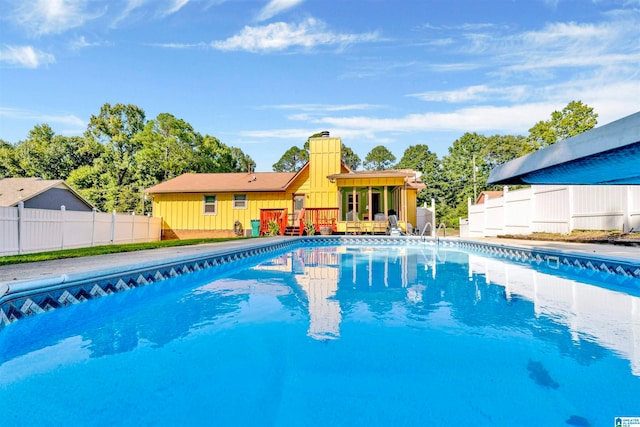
[145,132,424,239]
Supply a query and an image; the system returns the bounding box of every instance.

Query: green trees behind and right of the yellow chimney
[273,101,598,226]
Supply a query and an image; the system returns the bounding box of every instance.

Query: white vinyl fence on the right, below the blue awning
[461,185,640,237]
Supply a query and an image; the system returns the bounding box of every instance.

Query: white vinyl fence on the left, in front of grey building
[0,203,162,256]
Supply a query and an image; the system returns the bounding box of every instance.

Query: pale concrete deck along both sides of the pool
[0,237,640,284]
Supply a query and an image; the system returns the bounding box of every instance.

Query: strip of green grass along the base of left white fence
[0,237,241,265]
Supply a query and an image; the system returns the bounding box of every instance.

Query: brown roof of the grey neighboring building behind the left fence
[0,178,93,208]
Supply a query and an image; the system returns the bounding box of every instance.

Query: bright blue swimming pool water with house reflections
[0,246,640,426]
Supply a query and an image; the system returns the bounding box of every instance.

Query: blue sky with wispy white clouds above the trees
[0,0,640,171]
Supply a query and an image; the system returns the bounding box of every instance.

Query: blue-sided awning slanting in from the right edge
[488,112,640,185]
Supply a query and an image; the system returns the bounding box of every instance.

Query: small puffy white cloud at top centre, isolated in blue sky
[211,18,378,52]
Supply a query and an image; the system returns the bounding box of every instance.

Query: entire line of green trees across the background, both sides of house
[0,101,598,225]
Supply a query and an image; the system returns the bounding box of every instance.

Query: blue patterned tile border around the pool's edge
[0,236,640,328]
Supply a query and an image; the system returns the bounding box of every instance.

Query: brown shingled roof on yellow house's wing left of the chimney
[144,172,296,194]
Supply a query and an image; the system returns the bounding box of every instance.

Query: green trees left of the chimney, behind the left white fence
[0,103,255,212]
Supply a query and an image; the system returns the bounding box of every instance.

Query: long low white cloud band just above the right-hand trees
[242,77,640,142]
